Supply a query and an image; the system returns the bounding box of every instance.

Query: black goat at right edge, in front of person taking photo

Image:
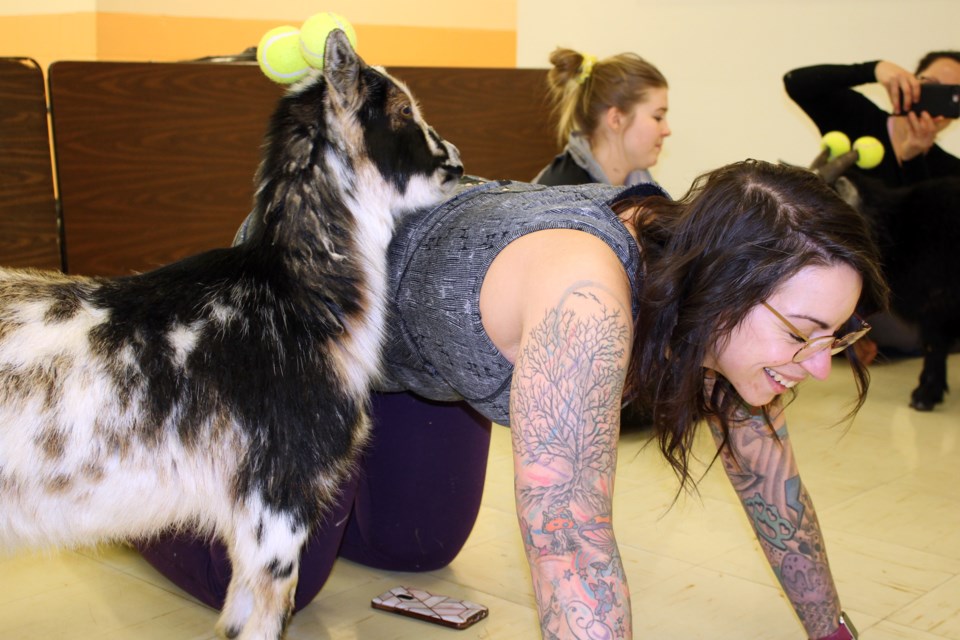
[814,151,960,411]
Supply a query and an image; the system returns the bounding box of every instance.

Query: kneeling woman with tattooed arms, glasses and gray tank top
[143,161,887,638]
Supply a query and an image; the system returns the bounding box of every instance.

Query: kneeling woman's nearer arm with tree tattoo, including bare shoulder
[481,231,632,639]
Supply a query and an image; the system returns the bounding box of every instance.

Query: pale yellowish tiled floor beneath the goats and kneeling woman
[0,355,960,640]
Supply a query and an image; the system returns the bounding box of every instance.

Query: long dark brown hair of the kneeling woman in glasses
[620,161,888,484]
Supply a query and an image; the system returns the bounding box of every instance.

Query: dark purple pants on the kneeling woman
[138,394,490,610]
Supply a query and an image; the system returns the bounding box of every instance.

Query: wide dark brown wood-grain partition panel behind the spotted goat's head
[49,61,557,275]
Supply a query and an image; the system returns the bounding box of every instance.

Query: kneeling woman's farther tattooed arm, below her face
[710,399,840,638]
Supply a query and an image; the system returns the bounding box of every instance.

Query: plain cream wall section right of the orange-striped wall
[517,0,960,196]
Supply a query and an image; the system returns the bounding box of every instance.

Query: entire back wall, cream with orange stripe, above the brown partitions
[0,0,960,196]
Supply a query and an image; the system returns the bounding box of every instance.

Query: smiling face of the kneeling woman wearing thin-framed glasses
[704,264,861,407]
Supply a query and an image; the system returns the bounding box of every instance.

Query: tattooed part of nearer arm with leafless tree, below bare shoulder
[511,287,631,638]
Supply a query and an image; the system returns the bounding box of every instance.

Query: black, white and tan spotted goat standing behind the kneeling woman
[0,31,463,640]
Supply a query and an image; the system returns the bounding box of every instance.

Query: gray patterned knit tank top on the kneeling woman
[378,180,666,425]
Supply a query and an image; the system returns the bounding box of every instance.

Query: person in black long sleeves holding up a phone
[783,51,960,187]
